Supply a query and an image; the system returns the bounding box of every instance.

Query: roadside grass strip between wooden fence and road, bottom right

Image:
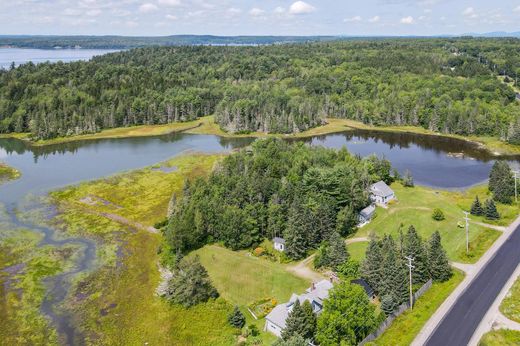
[367,270,464,346]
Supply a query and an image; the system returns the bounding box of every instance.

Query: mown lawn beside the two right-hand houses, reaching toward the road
[354,183,516,263]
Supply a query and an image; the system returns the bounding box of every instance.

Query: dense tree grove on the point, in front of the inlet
[166,139,391,259]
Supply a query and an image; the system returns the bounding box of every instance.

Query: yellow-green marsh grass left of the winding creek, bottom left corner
[0,229,77,345]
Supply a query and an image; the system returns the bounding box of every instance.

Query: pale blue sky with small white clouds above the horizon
[0,0,520,35]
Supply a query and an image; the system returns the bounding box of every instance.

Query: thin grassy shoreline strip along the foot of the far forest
[0,115,520,157]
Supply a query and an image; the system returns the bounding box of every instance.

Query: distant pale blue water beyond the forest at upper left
[0,48,117,69]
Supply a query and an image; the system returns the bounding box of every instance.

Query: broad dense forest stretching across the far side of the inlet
[0,38,520,143]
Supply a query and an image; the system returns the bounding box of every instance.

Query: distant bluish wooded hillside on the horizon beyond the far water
[0,35,338,49]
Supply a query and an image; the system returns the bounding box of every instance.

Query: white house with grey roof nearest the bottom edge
[265,280,332,337]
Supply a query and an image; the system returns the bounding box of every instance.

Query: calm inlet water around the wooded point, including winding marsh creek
[0,125,519,344]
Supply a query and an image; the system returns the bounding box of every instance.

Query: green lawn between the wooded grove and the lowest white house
[194,245,310,305]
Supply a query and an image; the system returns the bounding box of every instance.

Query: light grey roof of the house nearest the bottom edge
[265,280,333,329]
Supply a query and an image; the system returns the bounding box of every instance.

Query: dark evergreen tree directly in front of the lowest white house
[282,300,316,340]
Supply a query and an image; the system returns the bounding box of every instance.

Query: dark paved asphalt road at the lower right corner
[426,222,520,346]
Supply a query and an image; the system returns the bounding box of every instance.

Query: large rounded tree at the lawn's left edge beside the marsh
[166,256,218,307]
